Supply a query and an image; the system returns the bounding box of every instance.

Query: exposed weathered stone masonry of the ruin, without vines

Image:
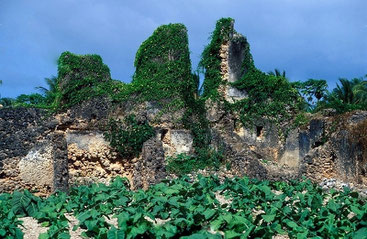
[0,19,367,195]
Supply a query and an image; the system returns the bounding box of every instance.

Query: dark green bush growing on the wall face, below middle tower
[104,115,155,157]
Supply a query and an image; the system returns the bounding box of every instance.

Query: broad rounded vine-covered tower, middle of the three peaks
[132,24,197,101]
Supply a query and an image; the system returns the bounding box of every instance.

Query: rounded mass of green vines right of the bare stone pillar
[231,69,302,125]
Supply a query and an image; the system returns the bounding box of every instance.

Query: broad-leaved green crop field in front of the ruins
[0,176,367,239]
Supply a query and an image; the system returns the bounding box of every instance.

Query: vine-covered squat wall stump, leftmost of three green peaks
[57,52,111,108]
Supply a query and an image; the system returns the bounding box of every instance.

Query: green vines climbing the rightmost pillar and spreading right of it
[199,18,302,129]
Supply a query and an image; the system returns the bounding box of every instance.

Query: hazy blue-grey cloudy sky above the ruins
[0,0,367,97]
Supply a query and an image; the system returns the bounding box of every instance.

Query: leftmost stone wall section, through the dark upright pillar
[0,108,68,194]
